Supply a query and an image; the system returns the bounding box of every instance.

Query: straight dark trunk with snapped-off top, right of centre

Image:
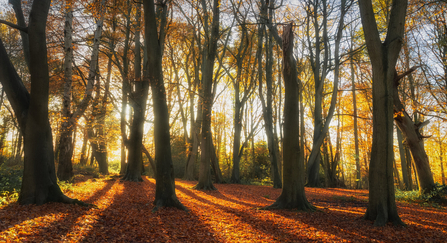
[267,24,314,211]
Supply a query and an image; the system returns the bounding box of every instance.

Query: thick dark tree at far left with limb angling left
[0,0,83,204]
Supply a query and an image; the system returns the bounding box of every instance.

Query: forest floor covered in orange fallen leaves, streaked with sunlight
[0,177,447,242]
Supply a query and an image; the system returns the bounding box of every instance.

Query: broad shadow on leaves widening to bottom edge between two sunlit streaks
[81,177,222,242]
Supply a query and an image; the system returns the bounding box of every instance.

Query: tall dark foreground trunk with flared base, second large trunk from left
[144,0,186,210]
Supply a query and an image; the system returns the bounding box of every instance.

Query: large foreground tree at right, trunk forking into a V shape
[359,0,408,226]
